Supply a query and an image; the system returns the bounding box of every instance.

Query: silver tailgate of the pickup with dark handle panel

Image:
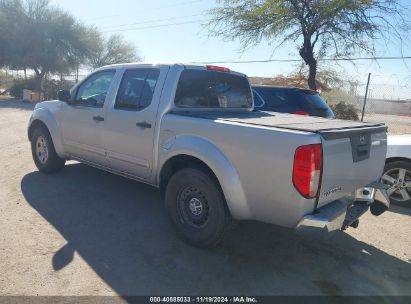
[318,126,387,207]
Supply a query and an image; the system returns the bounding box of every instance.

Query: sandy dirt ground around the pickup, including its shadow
[0,101,411,296]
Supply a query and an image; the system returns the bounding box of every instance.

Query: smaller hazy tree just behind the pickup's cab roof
[87,28,141,69]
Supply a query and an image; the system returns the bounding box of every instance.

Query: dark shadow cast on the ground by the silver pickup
[21,164,411,296]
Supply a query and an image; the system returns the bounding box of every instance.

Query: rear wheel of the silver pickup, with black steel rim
[165,168,231,247]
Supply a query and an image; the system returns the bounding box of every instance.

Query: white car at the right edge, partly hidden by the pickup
[381,135,411,208]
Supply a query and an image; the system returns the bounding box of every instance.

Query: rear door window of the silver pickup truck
[115,69,160,111]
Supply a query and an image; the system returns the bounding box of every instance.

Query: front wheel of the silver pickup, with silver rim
[31,126,66,173]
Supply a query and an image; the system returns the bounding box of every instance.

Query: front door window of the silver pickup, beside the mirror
[76,70,116,107]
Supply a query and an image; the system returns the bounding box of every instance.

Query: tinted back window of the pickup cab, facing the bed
[174,69,252,108]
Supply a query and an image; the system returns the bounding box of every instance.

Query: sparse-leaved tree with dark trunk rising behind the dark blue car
[207,0,409,90]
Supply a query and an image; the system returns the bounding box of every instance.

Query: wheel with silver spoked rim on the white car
[381,161,411,208]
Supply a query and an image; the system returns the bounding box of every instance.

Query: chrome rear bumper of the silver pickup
[295,184,390,232]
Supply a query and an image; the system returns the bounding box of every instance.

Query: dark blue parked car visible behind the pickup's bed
[252,85,334,118]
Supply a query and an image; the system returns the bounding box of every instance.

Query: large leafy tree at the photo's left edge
[0,0,92,91]
